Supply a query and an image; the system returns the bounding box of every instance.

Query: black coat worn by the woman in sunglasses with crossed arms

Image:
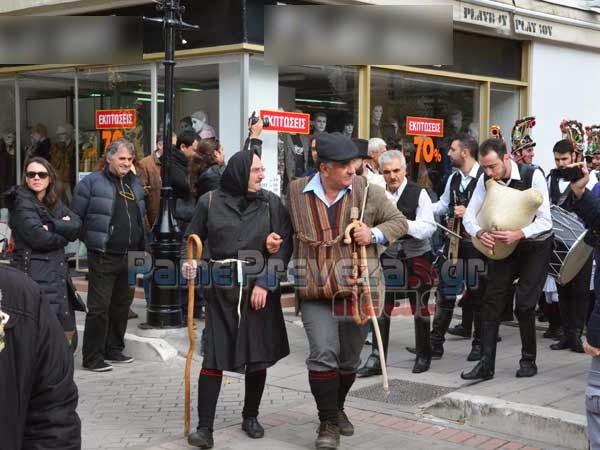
[6,186,81,331]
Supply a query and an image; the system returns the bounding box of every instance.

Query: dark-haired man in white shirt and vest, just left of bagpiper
[431,134,485,361]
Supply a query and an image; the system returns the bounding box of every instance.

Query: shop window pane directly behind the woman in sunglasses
[18,69,76,204]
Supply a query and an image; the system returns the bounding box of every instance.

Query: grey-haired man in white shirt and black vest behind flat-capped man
[357,150,436,377]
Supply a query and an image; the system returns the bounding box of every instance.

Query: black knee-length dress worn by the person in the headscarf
[188,189,293,371]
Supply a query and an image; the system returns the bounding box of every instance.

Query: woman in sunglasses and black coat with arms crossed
[5,157,81,350]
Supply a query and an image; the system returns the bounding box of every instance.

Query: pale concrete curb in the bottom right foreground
[421,392,589,450]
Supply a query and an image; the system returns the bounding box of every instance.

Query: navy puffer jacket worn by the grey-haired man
[71,168,145,253]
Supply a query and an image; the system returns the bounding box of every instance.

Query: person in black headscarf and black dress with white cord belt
[187,141,293,448]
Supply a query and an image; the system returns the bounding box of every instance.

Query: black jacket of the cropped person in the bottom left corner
[0,267,81,450]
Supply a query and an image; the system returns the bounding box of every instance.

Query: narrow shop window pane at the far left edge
[0,79,18,193]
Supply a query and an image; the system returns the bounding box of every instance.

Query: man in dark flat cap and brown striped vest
[288,133,408,449]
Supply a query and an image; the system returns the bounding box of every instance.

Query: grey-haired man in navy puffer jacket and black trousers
[71,139,145,372]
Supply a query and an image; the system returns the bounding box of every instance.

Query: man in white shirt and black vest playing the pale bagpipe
[461,139,553,380]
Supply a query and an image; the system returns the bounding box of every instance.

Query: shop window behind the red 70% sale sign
[370,70,479,196]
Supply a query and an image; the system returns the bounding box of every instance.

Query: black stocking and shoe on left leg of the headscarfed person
[188,369,223,449]
